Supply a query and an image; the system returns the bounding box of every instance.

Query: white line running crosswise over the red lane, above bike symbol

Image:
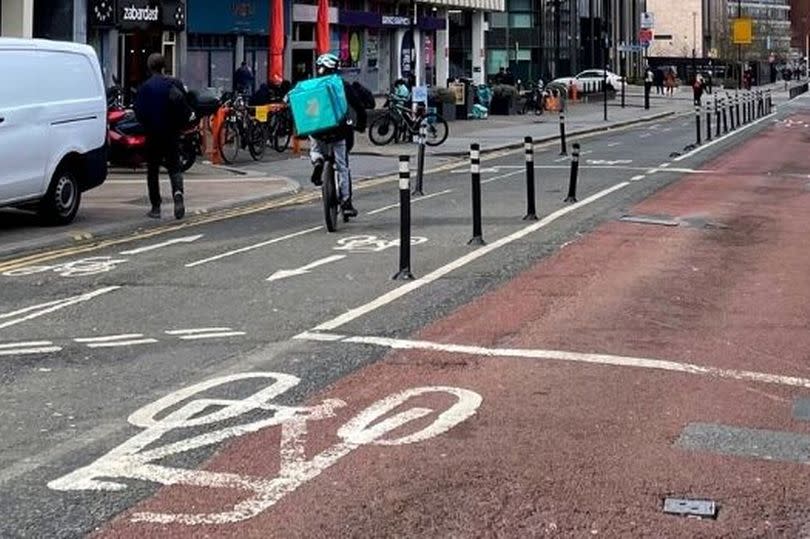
[316,337,810,388]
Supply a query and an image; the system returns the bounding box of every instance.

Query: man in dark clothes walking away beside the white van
[135,53,192,219]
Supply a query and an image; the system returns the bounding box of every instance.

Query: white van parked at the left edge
[0,38,107,224]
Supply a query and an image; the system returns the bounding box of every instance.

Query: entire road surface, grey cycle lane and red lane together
[0,100,810,537]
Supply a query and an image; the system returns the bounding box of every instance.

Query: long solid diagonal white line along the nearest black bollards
[314,182,630,331]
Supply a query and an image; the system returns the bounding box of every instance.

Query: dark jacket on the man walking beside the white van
[135,75,190,135]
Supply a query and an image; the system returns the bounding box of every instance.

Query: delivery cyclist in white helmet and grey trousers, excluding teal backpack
[309,53,367,217]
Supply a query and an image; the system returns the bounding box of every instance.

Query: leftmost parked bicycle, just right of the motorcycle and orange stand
[217,95,267,164]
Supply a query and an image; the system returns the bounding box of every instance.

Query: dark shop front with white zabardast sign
[87,0,186,88]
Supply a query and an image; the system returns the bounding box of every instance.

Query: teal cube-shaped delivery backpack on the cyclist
[288,75,349,135]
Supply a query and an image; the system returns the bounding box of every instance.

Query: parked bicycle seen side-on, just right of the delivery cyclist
[368,94,450,146]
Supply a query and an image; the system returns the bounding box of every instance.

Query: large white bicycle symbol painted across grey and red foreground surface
[48,372,482,525]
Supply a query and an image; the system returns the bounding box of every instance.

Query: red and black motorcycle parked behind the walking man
[107,80,216,172]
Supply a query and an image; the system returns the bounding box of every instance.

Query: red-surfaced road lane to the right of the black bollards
[94,113,810,537]
